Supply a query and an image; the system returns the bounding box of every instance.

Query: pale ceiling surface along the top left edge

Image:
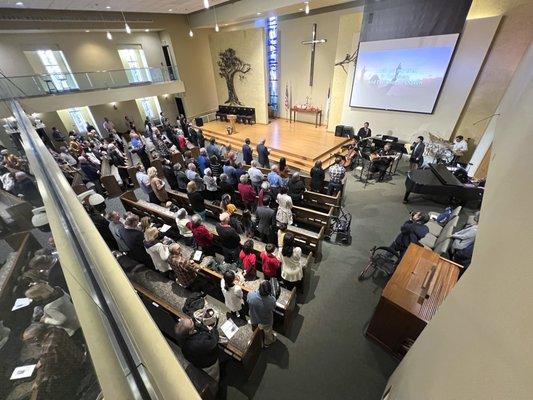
[0,0,228,14]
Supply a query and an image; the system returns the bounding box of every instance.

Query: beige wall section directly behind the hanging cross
[278,9,355,124]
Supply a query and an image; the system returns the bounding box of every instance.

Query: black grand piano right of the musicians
[403,164,483,208]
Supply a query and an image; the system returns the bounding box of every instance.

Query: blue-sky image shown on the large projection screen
[350,33,459,113]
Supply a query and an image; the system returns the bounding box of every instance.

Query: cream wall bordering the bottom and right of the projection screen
[341,16,501,140]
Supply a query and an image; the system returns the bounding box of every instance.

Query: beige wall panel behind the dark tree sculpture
[209,28,268,124]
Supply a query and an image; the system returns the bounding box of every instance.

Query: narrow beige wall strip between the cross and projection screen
[327,12,363,132]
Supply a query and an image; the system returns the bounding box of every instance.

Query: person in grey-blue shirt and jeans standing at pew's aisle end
[247,281,276,347]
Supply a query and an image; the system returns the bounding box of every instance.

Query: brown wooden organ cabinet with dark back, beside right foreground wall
[366,244,462,359]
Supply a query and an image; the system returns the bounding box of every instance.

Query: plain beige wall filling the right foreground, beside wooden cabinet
[387,45,533,400]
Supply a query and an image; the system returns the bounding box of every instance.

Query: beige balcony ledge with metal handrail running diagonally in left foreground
[9,100,200,400]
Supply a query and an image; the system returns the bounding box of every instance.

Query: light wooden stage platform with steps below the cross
[196,119,349,172]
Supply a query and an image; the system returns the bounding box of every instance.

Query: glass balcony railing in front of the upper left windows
[0,66,179,100]
